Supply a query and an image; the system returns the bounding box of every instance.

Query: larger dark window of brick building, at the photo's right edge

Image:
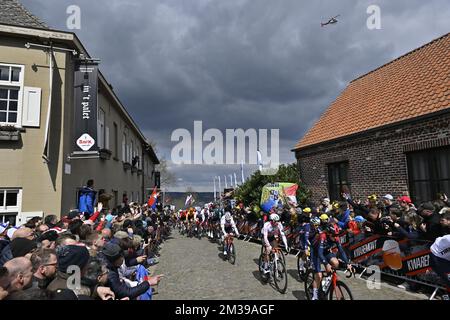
[406,147,450,203]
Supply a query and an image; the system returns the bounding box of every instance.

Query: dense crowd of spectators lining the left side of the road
[0,202,167,300]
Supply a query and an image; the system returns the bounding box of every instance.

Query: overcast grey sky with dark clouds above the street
[21,0,450,191]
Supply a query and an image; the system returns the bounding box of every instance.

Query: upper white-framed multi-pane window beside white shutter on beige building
[0,64,23,125]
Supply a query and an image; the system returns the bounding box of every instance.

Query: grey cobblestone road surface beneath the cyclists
[153,231,427,300]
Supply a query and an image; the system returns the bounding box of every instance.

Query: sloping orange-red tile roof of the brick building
[295,33,450,149]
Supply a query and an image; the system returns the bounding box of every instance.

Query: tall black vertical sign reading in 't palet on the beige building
[73,60,98,155]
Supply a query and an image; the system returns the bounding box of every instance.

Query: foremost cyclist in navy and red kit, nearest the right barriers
[311,223,352,300]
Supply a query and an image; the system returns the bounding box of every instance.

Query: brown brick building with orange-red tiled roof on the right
[292,33,450,203]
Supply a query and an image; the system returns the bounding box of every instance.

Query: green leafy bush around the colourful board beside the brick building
[235,163,311,205]
